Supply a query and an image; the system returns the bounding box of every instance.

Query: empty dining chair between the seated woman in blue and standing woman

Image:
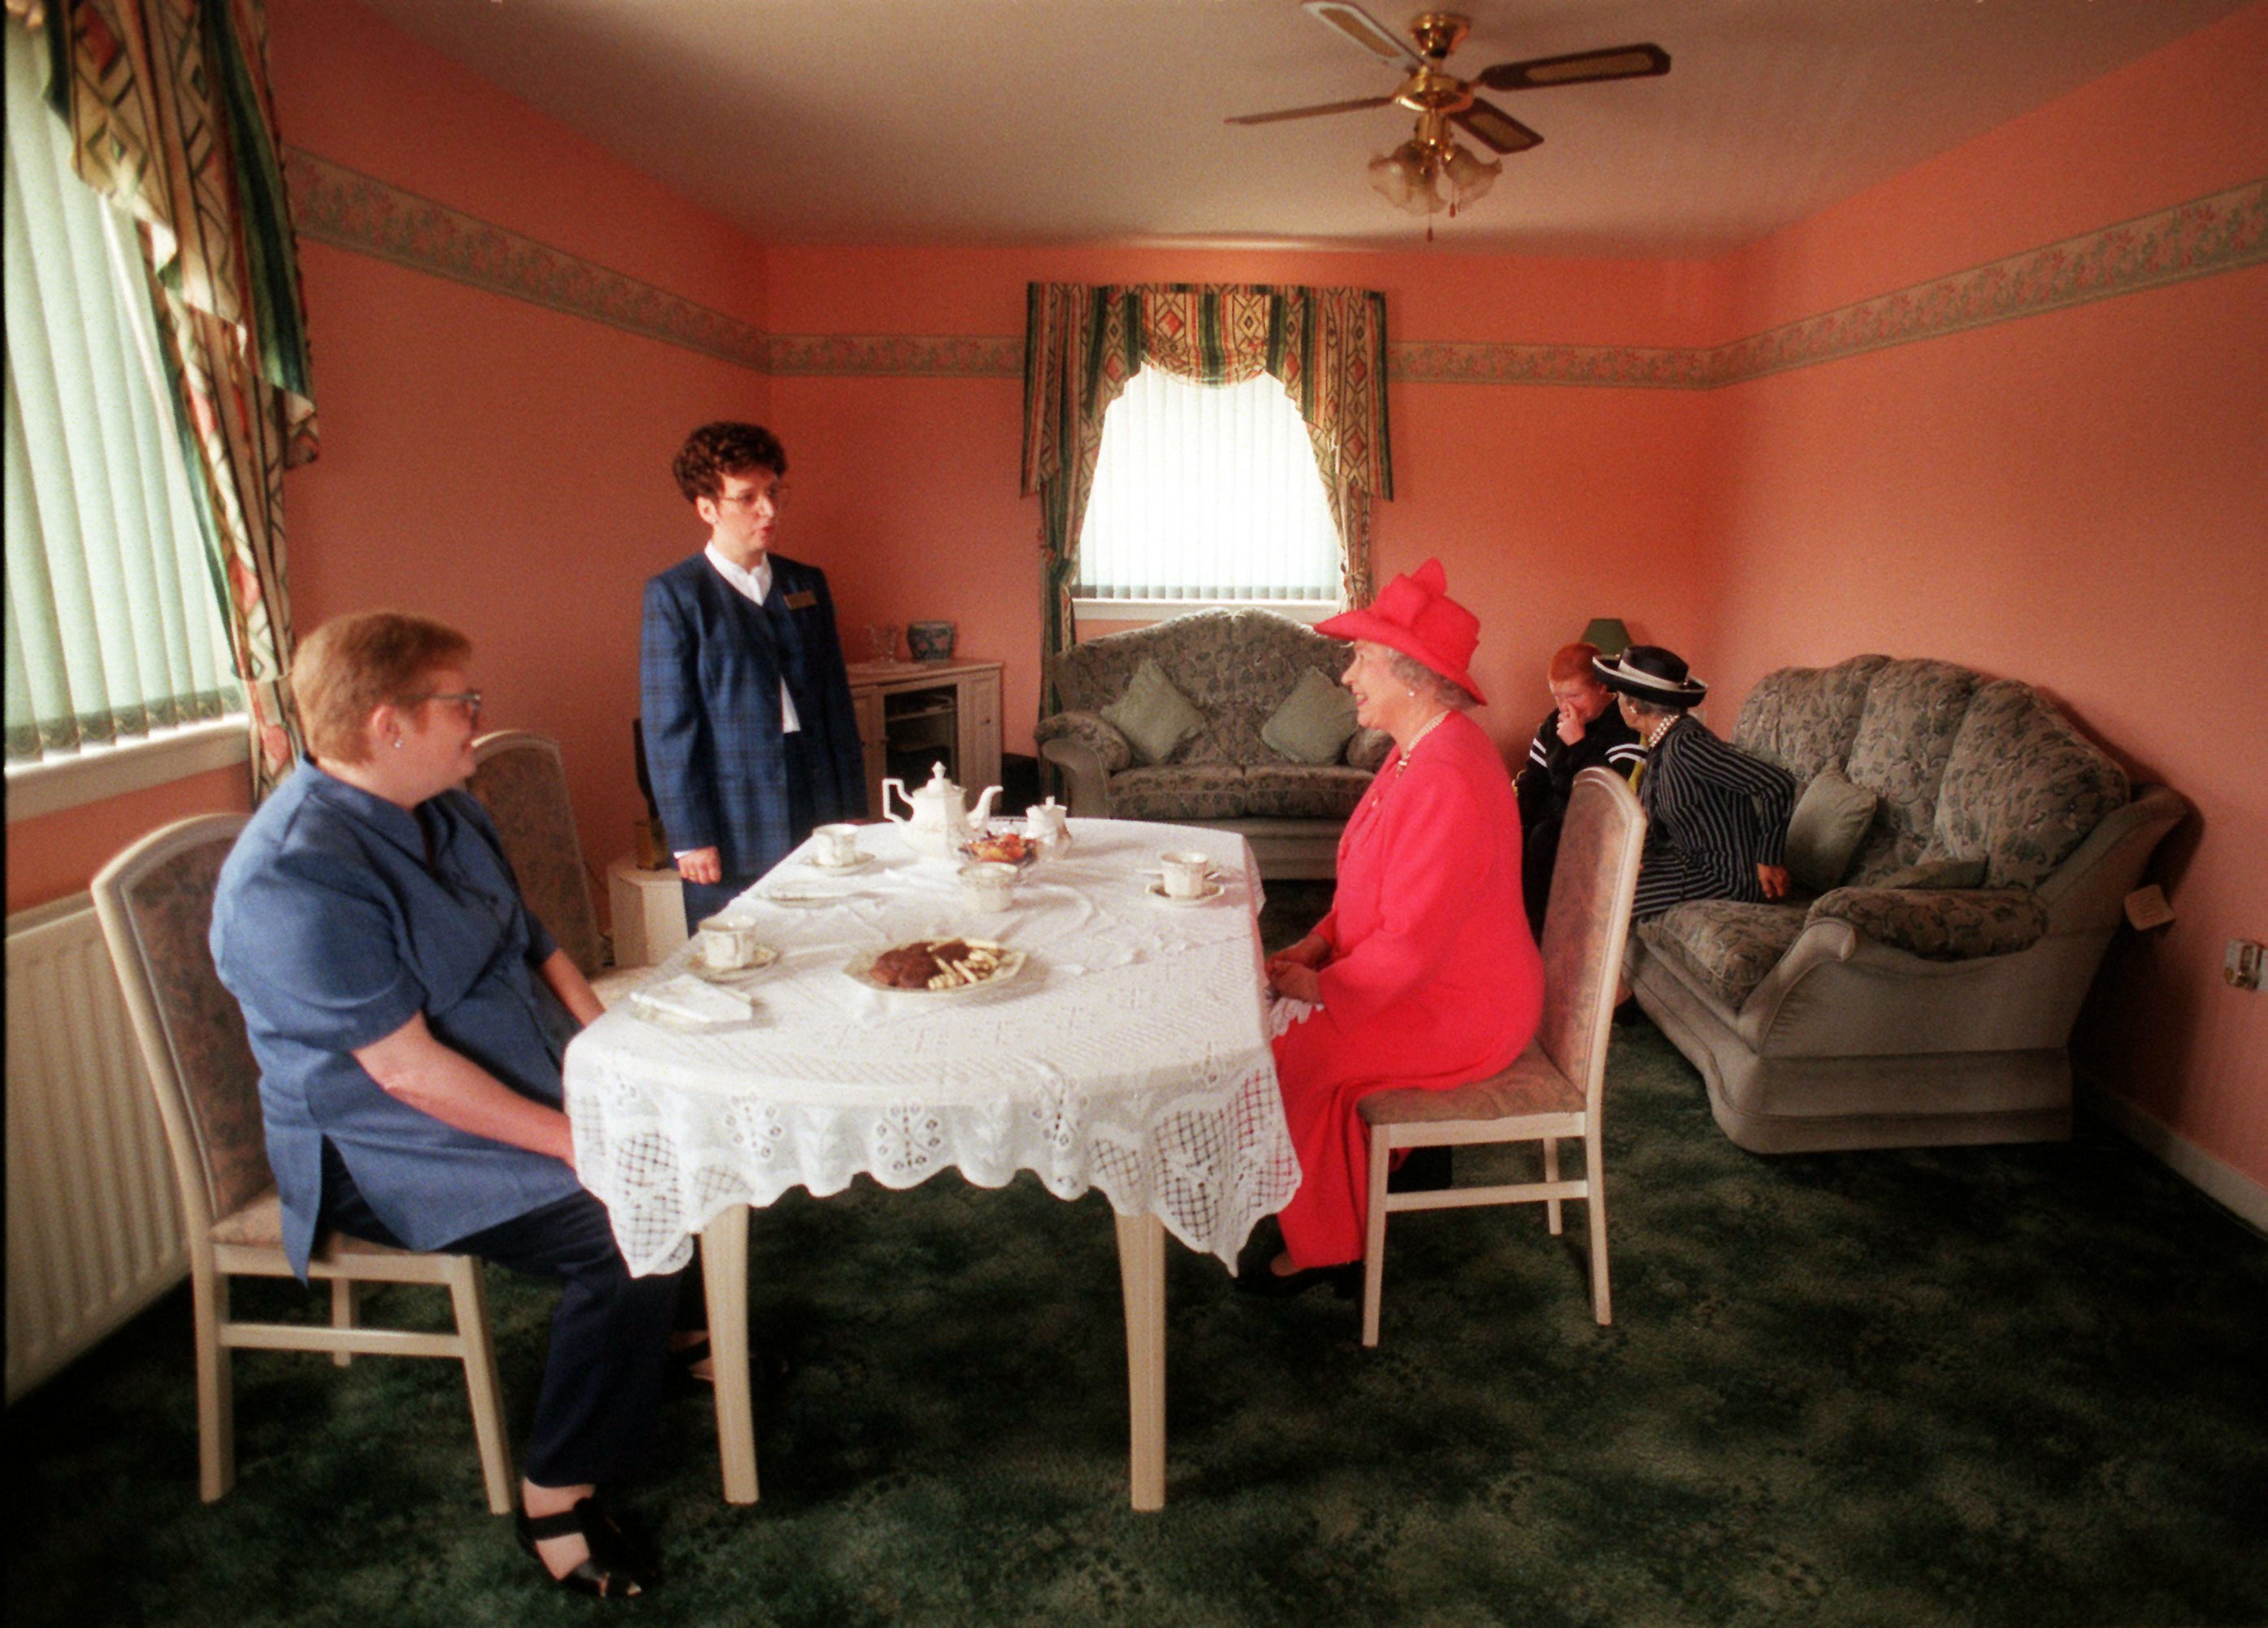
[467,730,651,1005]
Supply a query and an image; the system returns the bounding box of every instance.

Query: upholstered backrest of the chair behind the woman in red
[1535,769,1647,1111]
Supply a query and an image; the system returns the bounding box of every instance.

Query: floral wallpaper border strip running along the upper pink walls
[286,147,2268,390]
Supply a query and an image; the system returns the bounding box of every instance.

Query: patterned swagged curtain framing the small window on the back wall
[1023,283,1395,716]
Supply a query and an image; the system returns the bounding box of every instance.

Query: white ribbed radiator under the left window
[7,893,188,1401]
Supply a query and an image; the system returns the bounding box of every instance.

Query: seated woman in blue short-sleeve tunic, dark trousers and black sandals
[213,610,681,1599]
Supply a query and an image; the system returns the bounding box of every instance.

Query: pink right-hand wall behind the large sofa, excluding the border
[1712,7,2268,1181]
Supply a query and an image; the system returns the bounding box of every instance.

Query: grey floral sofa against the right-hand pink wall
[1628,655,2189,1152]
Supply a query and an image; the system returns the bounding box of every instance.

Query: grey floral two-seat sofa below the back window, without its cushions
[1037,610,1393,877]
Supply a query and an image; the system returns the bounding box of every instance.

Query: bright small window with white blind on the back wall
[1070,368,1341,617]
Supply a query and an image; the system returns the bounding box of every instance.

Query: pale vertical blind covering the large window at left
[0,18,243,764]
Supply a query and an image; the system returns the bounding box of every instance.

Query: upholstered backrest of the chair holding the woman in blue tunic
[93,814,275,1236]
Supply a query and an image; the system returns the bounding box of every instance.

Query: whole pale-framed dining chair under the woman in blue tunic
[93,814,517,1515]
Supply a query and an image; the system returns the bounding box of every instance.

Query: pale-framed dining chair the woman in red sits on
[1359,769,1647,1345]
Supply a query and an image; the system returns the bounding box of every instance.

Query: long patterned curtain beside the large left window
[33,0,315,796]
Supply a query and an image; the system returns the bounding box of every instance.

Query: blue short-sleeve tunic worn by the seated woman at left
[211,762,578,1276]
